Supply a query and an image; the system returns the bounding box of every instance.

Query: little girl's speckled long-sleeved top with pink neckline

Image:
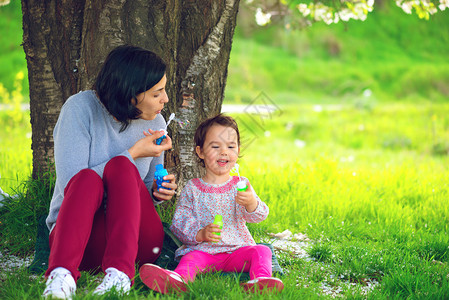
[170,176,269,259]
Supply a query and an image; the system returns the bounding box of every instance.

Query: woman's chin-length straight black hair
[93,45,166,131]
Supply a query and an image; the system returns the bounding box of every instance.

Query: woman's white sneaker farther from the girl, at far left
[42,267,76,300]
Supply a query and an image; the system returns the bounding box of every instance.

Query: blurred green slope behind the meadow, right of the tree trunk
[226,1,449,103]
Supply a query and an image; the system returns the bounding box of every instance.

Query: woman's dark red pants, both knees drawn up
[45,156,164,280]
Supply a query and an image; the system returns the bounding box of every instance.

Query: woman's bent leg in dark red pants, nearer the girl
[102,156,164,279]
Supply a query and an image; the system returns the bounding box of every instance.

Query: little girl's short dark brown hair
[194,114,240,167]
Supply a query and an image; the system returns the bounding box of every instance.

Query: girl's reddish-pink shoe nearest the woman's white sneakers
[139,264,187,294]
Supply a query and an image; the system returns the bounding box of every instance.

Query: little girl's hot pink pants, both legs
[175,245,272,281]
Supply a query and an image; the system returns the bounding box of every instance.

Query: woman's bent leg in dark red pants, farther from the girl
[45,169,104,281]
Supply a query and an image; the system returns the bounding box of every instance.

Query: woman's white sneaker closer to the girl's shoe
[93,268,131,295]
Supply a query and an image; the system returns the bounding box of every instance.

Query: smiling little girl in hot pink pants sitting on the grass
[140,114,284,294]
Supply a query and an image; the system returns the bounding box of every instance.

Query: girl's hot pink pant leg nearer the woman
[175,251,220,281]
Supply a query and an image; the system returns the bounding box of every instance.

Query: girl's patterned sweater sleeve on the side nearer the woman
[170,183,201,245]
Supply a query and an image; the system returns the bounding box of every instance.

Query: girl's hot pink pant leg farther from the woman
[220,245,272,279]
